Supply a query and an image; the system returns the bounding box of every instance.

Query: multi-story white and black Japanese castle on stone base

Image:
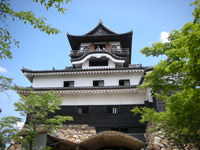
[19,21,155,150]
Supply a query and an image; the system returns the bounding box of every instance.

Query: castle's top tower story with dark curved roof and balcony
[67,21,133,69]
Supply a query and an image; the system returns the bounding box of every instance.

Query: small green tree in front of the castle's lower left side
[14,92,73,150]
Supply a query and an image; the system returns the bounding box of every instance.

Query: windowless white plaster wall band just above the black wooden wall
[61,93,145,106]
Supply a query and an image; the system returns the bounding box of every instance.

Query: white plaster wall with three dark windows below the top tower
[32,72,142,88]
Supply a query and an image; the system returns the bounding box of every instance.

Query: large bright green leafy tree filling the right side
[132,0,200,149]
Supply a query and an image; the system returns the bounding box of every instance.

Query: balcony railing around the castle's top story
[70,48,130,57]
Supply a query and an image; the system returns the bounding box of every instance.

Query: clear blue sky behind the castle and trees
[0,0,193,118]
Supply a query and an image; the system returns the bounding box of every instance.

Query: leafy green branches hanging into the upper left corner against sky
[0,0,70,91]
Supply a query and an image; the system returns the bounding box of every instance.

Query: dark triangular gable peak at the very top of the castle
[83,20,117,36]
